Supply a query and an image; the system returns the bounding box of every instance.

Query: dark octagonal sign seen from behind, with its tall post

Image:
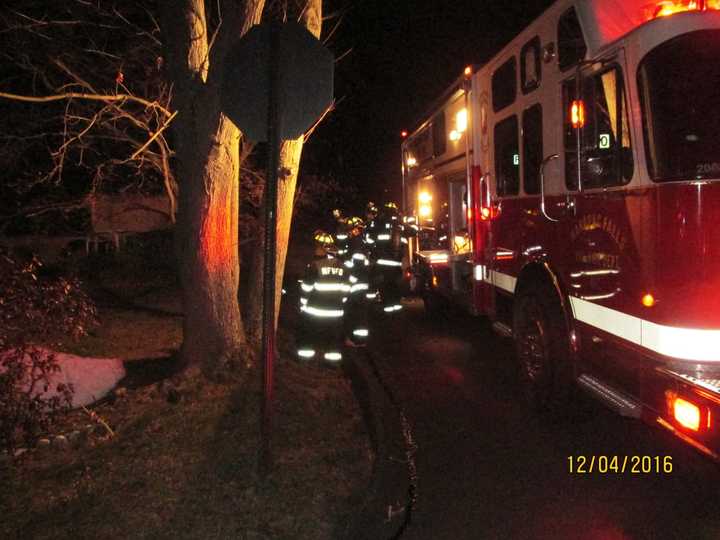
[222,23,334,477]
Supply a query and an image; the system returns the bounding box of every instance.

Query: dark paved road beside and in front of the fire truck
[368,301,720,540]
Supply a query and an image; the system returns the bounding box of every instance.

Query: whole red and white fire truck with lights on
[402,0,720,458]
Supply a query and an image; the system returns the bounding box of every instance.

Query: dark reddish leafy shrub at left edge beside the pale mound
[0,249,96,452]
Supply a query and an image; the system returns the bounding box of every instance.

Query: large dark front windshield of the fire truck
[638,30,720,182]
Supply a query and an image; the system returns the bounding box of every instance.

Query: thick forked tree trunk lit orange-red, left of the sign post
[162,0,264,373]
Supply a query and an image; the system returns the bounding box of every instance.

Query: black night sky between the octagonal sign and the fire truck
[304,0,552,205]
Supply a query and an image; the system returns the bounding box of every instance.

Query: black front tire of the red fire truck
[513,284,572,413]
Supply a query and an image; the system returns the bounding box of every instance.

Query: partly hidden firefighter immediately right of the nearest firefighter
[345,217,375,347]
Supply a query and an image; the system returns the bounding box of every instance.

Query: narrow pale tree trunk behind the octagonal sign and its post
[242,0,322,349]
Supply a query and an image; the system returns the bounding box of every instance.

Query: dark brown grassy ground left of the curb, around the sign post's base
[0,236,373,539]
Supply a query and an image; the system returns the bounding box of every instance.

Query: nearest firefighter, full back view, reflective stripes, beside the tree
[297,230,350,363]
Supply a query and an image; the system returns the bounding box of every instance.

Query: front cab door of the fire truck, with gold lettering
[563,64,633,304]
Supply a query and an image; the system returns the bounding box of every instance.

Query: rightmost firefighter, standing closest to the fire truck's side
[372,202,404,313]
